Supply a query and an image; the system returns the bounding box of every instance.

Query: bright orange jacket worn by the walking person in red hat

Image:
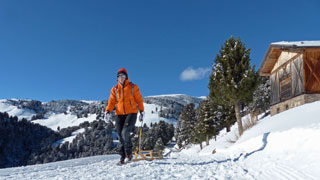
[105,79,144,115]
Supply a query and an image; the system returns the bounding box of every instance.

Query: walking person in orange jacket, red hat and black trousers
[104,68,144,164]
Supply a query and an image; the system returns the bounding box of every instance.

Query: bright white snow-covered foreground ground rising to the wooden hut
[0,102,320,180]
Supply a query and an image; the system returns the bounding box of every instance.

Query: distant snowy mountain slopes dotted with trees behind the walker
[0,94,202,131]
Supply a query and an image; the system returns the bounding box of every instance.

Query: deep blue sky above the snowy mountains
[0,0,320,101]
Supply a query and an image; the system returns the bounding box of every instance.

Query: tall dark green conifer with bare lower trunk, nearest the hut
[209,37,257,136]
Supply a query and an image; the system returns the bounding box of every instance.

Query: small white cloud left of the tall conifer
[180,67,211,81]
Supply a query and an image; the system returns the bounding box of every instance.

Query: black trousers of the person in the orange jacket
[116,114,137,158]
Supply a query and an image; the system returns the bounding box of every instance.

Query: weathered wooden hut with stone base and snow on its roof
[259,41,320,115]
